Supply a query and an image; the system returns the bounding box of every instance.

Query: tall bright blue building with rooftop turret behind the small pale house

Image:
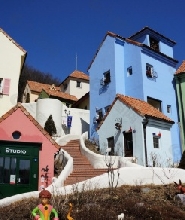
[88,27,182,162]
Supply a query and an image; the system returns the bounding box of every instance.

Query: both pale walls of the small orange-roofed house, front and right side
[98,100,173,167]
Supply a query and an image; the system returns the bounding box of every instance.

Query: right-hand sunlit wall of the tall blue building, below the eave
[141,50,181,162]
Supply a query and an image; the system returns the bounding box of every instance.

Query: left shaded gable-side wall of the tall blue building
[89,36,116,139]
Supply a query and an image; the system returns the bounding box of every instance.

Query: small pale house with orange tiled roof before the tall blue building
[94,94,174,166]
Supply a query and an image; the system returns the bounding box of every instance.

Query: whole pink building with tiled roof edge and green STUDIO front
[0,103,60,199]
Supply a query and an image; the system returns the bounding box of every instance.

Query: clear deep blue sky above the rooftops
[0,0,185,81]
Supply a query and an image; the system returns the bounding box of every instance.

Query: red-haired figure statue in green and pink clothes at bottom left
[32,189,59,220]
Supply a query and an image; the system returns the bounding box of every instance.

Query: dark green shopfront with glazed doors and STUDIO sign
[0,144,39,199]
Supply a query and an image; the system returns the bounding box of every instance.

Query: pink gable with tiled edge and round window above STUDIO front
[0,104,60,149]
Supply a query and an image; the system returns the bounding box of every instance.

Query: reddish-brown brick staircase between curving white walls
[62,140,107,186]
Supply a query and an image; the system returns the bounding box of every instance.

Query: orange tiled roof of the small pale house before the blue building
[98,94,174,129]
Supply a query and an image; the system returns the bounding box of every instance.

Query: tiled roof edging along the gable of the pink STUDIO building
[0,103,61,149]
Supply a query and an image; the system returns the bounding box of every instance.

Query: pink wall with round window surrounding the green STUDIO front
[0,108,58,189]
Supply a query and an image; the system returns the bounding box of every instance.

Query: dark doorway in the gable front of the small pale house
[124,132,133,157]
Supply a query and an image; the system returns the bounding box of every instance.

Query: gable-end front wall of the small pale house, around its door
[98,100,145,165]
